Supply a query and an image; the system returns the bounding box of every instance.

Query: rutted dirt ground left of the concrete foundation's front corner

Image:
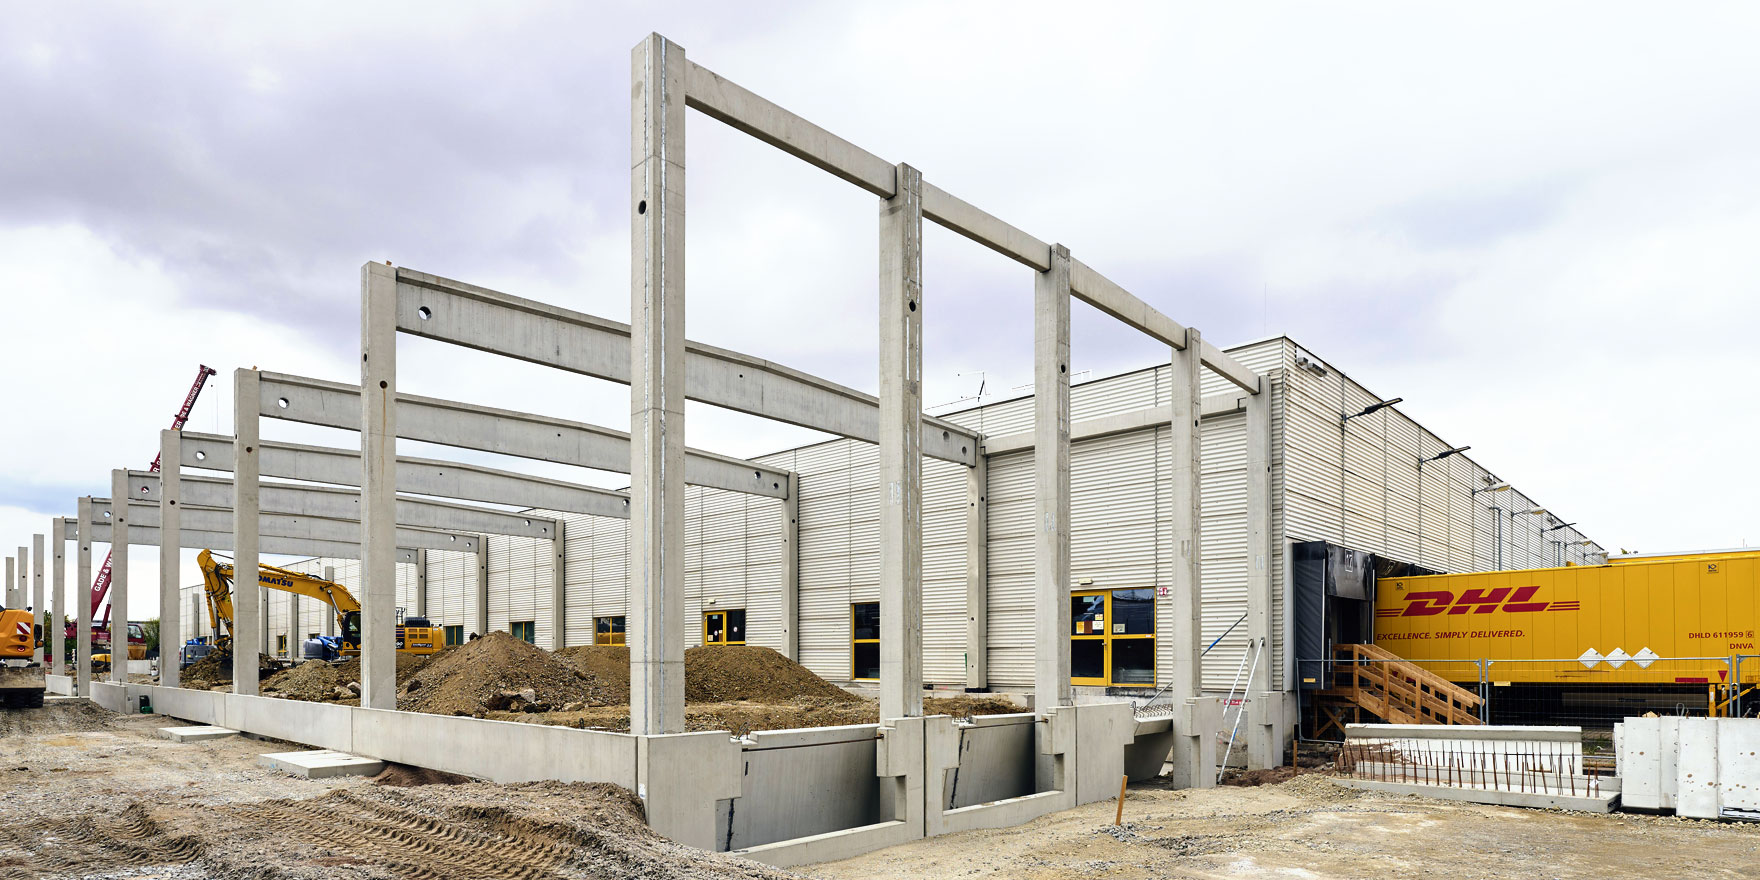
[0,700,794,880]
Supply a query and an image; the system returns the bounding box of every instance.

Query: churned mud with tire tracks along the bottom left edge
[0,783,792,880]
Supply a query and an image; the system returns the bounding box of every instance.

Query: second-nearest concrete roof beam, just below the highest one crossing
[262,373,788,498]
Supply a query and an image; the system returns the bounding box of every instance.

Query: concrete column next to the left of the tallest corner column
[361,262,398,709]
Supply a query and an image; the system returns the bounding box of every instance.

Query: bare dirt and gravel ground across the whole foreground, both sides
[10,699,1760,880]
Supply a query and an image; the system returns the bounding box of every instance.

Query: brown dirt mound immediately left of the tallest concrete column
[398,632,593,716]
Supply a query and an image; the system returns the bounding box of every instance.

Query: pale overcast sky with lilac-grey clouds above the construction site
[0,2,1760,618]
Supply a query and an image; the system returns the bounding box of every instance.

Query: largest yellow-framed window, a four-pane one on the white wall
[1070,590,1155,688]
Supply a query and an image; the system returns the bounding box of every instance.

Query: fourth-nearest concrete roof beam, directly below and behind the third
[128,470,542,538]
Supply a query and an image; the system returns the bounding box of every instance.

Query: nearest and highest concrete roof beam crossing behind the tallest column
[388,267,977,466]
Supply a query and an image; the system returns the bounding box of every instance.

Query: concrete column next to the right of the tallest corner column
[880,164,922,722]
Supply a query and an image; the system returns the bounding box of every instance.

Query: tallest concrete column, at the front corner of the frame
[627,33,686,736]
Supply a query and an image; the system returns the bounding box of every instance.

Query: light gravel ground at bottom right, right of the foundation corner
[801,774,1760,880]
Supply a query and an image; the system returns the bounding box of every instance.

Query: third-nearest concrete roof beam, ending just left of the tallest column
[183,431,628,517]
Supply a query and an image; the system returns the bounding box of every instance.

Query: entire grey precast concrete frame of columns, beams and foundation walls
[55,35,1323,864]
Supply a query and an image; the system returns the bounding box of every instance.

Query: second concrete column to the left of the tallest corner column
[234,370,264,697]
